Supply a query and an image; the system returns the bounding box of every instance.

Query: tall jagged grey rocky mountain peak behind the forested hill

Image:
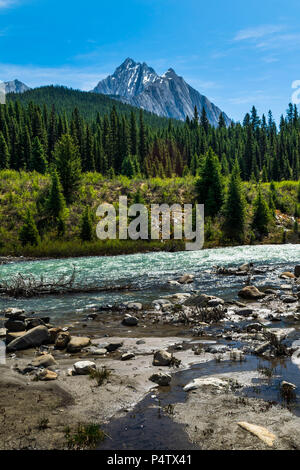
[92,58,231,126]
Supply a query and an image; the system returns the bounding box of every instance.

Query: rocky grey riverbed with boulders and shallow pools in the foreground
[0,263,300,449]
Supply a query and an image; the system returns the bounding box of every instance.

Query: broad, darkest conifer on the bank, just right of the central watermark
[196,148,224,217]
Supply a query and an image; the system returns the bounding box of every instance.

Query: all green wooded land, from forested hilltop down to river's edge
[0,87,300,254]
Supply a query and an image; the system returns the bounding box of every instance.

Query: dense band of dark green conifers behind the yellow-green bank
[0,97,300,182]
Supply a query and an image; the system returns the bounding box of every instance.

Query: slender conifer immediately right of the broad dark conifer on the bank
[223,159,246,242]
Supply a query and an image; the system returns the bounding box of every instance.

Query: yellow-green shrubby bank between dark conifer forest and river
[0,170,300,257]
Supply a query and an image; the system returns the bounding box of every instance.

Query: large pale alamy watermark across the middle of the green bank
[96,196,204,251]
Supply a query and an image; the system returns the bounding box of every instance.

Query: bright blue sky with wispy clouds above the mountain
[0,0,300,120]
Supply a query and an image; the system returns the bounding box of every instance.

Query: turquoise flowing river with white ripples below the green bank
[0,245,300,320]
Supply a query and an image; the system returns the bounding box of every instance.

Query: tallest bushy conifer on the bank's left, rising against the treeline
[53,134,81,204]
